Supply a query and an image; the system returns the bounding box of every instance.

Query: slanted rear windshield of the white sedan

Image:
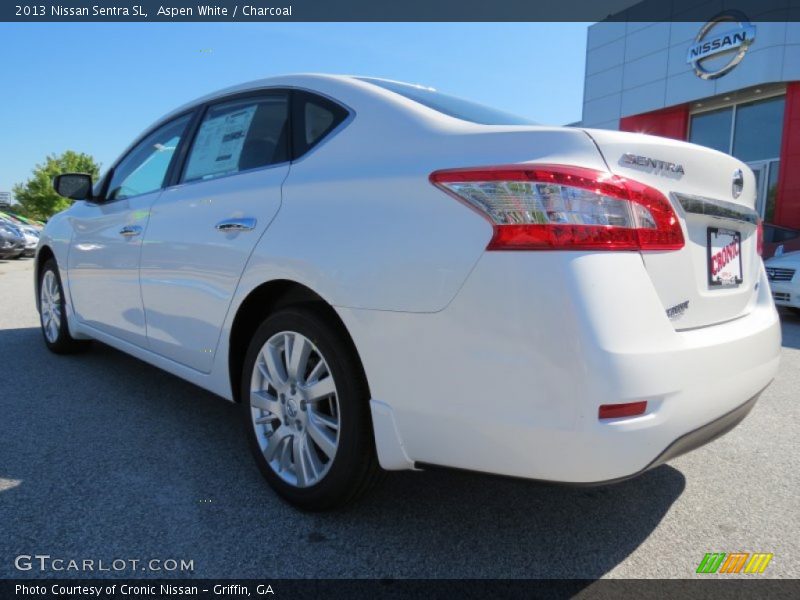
[357,77,537,125]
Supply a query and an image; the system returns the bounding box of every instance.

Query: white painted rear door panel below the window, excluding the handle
[140,166,289,373]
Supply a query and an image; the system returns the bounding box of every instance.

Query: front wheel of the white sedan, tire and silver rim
[39,258,91,354]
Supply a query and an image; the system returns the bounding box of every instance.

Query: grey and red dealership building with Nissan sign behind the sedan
[581,8,800,229]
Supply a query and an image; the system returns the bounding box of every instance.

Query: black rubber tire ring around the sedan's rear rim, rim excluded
[240,308,374,510]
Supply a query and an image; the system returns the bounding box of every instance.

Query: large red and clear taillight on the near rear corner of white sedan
[430,165,684,250]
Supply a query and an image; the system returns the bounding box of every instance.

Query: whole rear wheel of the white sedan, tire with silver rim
[240,307,383,511]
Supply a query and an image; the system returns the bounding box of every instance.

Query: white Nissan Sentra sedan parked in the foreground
[36,75,781,509]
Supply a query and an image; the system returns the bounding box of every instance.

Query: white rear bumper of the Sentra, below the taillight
[340,252,781,483]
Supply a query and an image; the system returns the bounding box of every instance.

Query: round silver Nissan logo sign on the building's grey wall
[686,10,756,79]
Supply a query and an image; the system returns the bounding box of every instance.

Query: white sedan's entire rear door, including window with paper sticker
[140,92,289,373]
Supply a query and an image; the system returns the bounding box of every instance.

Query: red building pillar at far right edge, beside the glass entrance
[775,82,800,229]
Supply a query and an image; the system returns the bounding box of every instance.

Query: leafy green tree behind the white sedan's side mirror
[14,150,100,220]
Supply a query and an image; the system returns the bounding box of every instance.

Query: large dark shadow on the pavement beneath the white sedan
[0,328,685,579]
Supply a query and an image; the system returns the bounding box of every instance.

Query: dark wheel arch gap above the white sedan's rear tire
[228,279,369,402]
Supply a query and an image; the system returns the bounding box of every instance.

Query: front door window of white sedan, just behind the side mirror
[106,115,191,200]
